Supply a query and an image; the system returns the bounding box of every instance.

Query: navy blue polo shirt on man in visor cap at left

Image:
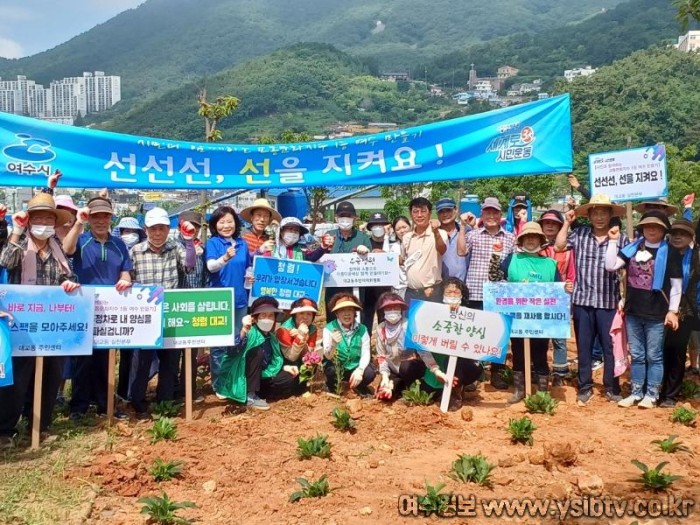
[73,232,134,285]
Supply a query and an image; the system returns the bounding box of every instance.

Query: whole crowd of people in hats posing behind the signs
[0,174,700,446]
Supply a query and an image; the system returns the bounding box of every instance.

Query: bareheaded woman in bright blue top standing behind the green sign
[205,206,253,393]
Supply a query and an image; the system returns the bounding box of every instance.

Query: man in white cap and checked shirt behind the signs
[131,208,194,419]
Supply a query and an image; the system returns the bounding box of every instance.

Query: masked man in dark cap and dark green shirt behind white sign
[323,201,374,323]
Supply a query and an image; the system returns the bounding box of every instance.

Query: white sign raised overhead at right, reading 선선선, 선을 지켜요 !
[588,144,668,202]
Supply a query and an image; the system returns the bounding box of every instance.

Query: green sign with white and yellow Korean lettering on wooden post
[163,288,235,348]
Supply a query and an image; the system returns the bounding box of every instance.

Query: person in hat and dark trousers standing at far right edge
[659,219,700,408]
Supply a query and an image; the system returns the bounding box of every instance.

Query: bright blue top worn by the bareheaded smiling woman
[205,236,253,308]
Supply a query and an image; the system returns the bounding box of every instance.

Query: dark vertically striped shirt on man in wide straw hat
[568,226,629,310]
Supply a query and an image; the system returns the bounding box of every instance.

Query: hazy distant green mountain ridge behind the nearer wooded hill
[0,0,619,106]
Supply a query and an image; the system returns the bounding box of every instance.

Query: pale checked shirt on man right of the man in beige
[466,228,515,301]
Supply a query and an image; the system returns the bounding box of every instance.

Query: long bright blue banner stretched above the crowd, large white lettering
[0,95,573,190]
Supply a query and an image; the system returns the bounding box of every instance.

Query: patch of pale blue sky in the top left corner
[0,0,145,58]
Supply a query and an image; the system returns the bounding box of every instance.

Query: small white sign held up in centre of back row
[320,253,399,288]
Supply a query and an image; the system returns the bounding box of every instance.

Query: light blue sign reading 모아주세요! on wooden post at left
[0,284,95,357]
